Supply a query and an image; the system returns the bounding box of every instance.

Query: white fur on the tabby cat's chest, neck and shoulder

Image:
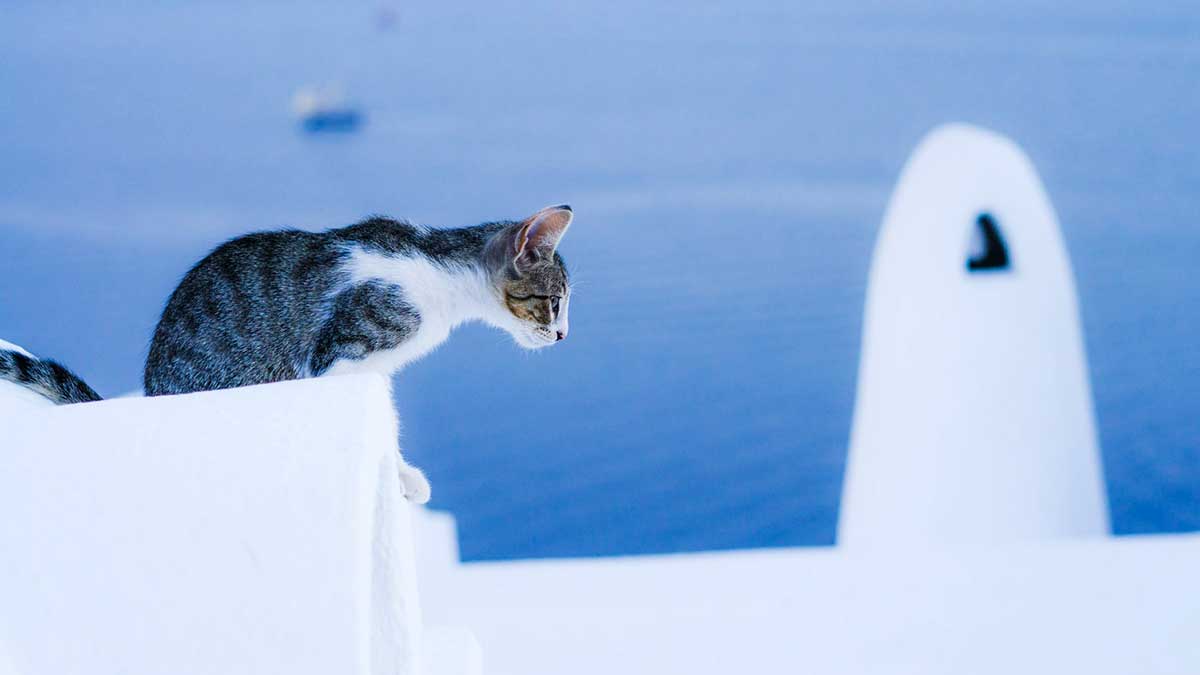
[326,249,499,375]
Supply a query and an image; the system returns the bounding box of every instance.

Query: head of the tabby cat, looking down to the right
[484,204,574,350]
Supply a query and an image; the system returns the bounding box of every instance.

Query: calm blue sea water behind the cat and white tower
[0,0,1200,560]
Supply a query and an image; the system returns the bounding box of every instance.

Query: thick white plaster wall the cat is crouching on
[0,376,422,675]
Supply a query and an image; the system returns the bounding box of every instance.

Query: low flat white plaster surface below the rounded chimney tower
[412,536,1200,675]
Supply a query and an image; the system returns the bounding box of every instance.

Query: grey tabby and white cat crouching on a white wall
[0,204,574,502]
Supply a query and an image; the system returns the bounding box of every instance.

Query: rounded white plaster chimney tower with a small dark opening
[838,125,1109,549]
